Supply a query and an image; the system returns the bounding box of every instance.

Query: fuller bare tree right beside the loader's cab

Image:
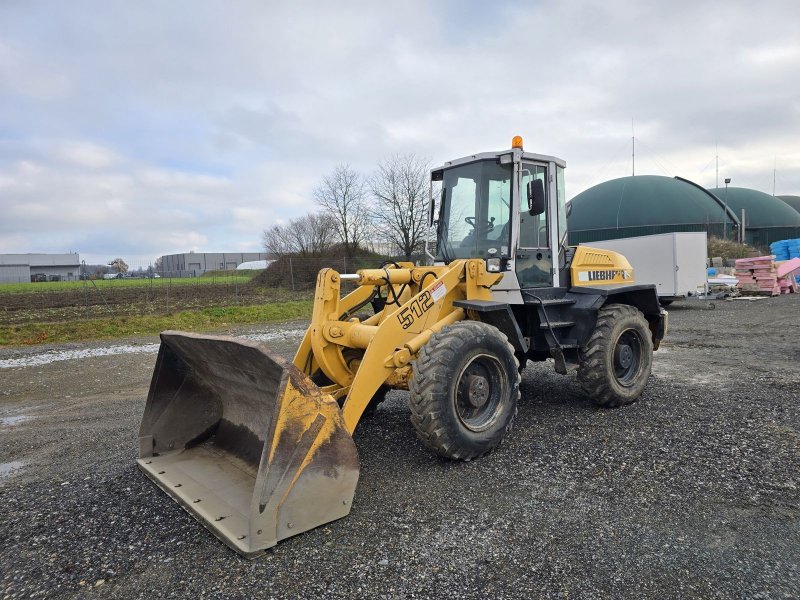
[370,154,430,260]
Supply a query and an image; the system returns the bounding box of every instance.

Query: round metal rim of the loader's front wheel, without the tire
[455,354,505,431]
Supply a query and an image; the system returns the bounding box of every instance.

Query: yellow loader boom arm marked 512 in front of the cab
[294,260,501,433]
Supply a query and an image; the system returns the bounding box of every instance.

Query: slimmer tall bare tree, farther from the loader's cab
[314,165,370,258]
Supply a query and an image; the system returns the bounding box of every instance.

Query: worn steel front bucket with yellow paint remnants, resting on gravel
[137,331,358,556]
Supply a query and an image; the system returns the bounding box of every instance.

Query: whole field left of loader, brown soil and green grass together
[0,271,313,346]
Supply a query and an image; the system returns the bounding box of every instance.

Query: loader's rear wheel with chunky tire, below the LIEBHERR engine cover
[578,304,653,408]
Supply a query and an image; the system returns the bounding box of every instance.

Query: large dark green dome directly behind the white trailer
[567,175,739,245]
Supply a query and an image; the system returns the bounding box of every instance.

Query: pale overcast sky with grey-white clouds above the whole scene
[0,0,800,266]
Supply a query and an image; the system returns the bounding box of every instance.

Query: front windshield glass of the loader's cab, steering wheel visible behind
[437,160,513,262]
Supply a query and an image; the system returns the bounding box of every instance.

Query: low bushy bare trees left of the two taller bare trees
[263,213,336,257]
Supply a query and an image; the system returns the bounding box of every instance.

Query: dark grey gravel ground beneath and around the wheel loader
[0,296,800,598]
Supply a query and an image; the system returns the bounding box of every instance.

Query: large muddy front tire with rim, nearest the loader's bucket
[408,321,520,460]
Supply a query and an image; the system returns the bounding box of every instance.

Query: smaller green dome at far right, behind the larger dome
[709,187,800,248]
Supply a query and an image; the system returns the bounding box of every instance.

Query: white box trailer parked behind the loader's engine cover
[583,232,708,304]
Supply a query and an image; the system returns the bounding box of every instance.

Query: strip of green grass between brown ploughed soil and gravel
[0,300,313,346]
